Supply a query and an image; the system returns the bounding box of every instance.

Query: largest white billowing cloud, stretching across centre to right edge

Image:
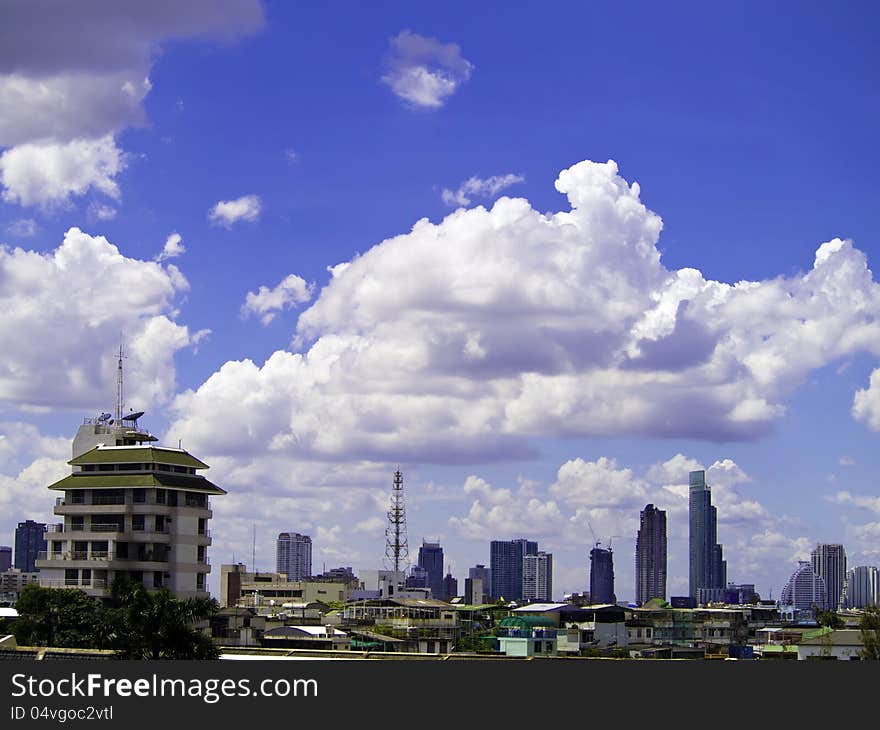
[168,161,880,466]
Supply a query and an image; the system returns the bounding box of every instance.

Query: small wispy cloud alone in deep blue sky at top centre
[382,30,474,109]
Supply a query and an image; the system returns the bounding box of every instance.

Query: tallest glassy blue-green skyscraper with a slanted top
[688,469,727,598]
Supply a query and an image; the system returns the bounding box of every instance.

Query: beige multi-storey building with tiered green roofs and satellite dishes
[36,413,226,598]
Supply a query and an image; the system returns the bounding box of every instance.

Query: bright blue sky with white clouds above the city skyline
[0,0,880,598]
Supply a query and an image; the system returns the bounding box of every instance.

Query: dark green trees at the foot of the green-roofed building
[12,579,218,659]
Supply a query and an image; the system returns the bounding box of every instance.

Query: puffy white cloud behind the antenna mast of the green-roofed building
[0,228,202,412]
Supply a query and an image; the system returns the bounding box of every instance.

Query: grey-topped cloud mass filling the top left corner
[0,0,264,206]
